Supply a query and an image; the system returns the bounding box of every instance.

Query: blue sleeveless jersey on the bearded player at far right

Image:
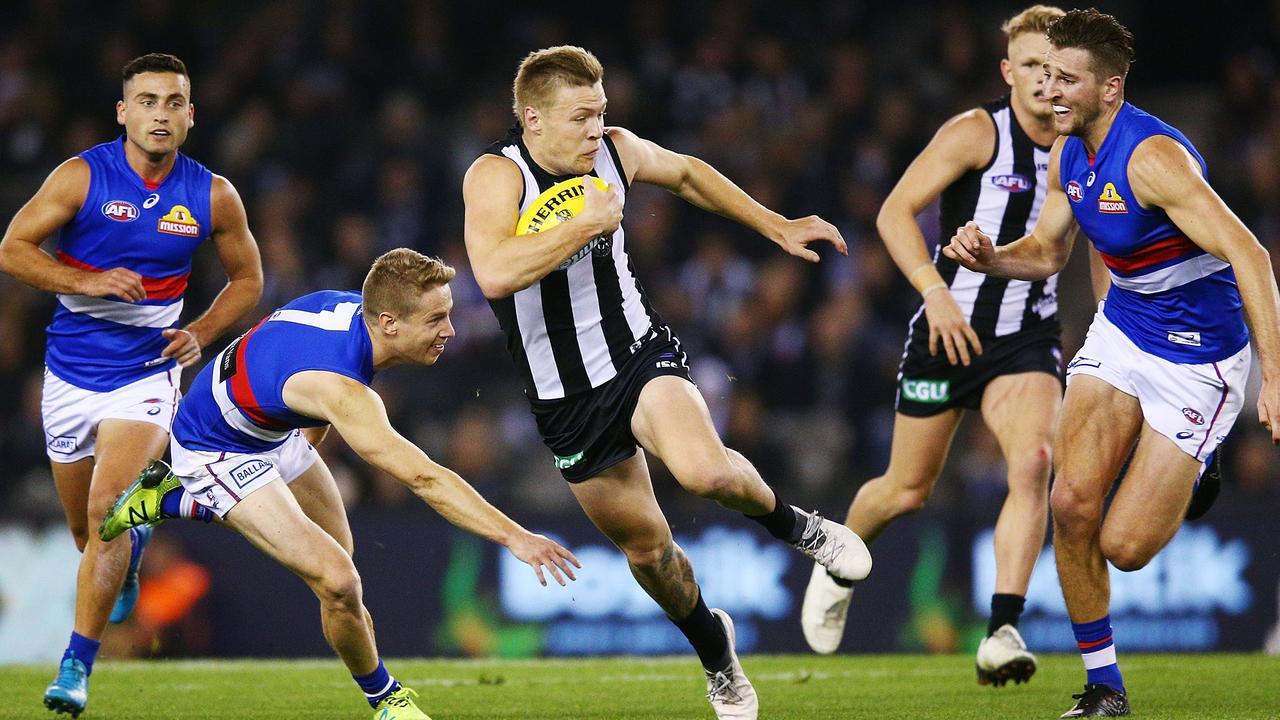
[1060,102,1249,363]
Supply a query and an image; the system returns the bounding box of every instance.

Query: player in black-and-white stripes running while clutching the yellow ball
[462,46,872,719]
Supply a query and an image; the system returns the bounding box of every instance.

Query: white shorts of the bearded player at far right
[1066,304,1253,462]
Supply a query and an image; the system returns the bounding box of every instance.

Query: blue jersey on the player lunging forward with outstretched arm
[173,290,374,452]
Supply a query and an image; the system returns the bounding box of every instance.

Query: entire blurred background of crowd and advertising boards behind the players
[0,0,1280,662]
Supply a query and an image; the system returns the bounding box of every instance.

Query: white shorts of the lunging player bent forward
[169,430,320,518]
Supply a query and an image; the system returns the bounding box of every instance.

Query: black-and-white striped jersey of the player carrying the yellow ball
[486,126,662,400]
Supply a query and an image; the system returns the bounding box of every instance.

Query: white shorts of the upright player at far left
[40,365,182,462]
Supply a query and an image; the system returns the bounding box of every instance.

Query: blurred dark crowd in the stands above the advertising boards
[0,0,1280,520]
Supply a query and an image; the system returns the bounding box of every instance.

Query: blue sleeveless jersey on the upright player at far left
[45,137,214,392]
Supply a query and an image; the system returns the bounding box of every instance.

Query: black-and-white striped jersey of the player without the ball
[911,95,1057,338]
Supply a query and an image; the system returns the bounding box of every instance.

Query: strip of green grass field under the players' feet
[0,653,1280,720]
